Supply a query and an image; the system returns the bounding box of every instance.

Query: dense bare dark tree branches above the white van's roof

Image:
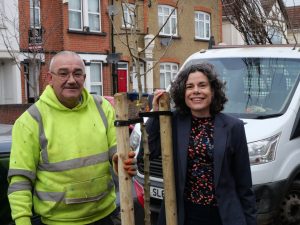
[222,0,296,45]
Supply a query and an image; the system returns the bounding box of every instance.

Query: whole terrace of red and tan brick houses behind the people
[0,0,222,123]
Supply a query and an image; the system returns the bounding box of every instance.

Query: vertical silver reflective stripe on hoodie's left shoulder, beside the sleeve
[28,104,49,163]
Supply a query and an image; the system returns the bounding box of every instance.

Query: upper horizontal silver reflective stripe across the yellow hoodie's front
[38,152,108,172]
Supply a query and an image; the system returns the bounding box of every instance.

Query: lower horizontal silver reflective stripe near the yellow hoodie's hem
[34,180,114,204]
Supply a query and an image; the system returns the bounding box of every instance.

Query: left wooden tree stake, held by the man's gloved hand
[114,93,135,225]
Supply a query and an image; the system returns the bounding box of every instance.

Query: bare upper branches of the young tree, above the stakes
[110,0,185,99]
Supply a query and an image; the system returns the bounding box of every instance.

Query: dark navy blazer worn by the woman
[146,111,257,225]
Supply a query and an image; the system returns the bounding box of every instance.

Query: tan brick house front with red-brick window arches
[113,0,222,93]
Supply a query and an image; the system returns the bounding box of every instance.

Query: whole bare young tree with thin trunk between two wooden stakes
[109,0,185,225]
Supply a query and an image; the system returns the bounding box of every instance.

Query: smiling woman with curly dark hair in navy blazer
[146,63,256,225]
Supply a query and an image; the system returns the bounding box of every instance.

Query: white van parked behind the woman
[130,45,300,225]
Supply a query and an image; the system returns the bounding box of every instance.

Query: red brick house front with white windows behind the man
[0,0,113,123]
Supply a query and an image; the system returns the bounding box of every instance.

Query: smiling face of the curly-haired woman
[185,71,213,117]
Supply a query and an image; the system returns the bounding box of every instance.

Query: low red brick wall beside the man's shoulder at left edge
[0,104,31,124]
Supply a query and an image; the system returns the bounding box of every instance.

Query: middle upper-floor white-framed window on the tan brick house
[158,5,178,36]
